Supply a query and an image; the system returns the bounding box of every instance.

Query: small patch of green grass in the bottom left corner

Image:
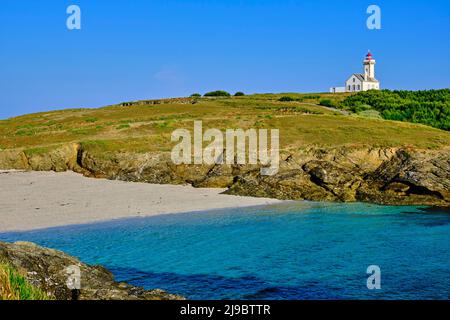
[0,263,52,300]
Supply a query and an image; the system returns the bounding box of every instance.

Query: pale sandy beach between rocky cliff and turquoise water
[0,171,280,232]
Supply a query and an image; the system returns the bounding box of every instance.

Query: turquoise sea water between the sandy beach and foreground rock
[0,202,450,299]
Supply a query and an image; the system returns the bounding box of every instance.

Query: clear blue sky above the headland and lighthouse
[0,0,450,118]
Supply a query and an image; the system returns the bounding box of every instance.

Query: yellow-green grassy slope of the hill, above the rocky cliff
[0,93,450,153]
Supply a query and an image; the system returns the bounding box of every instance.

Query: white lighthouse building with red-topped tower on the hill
[330,52,380,93]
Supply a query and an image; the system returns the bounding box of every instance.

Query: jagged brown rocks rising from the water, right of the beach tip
[227,149,450,205]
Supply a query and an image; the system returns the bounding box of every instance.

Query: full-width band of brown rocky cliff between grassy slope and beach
[0,145,450,206]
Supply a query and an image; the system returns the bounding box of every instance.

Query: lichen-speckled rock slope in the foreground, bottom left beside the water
[0,242,183,300]
